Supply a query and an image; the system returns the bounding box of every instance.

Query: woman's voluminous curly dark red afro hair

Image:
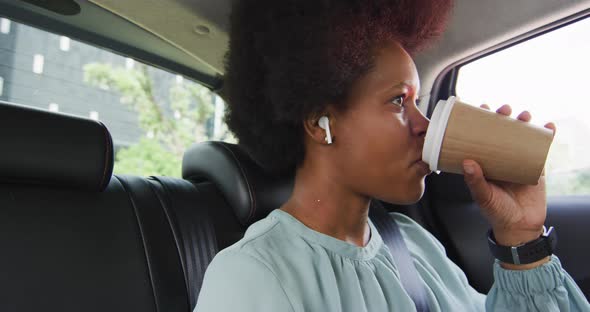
[223,0,452,172]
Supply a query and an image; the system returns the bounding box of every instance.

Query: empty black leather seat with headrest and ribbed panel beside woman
[0,103,226,312]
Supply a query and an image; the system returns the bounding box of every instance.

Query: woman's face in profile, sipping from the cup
[331,42,430,204]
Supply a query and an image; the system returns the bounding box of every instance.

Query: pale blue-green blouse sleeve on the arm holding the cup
[392,213,590,312]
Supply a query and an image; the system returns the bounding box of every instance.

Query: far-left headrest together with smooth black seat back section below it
[0,103,169,311]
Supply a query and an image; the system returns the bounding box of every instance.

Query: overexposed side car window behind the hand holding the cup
[456,18,590,195]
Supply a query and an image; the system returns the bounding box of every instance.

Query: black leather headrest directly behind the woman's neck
[182,142,294,226]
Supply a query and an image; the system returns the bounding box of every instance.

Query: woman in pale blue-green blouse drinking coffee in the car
[195,0,590,312]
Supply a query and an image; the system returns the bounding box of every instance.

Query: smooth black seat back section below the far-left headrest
[0,181,164,311]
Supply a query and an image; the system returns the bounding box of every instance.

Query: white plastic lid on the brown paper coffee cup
[422,96,457,173]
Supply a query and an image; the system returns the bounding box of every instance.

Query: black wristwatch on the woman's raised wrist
[488,226,557,264]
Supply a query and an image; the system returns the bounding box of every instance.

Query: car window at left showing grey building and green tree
[0,18,235,177]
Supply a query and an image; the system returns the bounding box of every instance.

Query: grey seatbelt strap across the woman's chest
[369,200,430,312]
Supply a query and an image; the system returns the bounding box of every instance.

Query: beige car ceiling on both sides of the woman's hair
[0,0,590,109]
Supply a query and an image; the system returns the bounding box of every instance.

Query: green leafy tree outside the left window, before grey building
[84,63,224,177]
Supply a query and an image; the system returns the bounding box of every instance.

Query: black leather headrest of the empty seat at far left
[0,101,113,191]
